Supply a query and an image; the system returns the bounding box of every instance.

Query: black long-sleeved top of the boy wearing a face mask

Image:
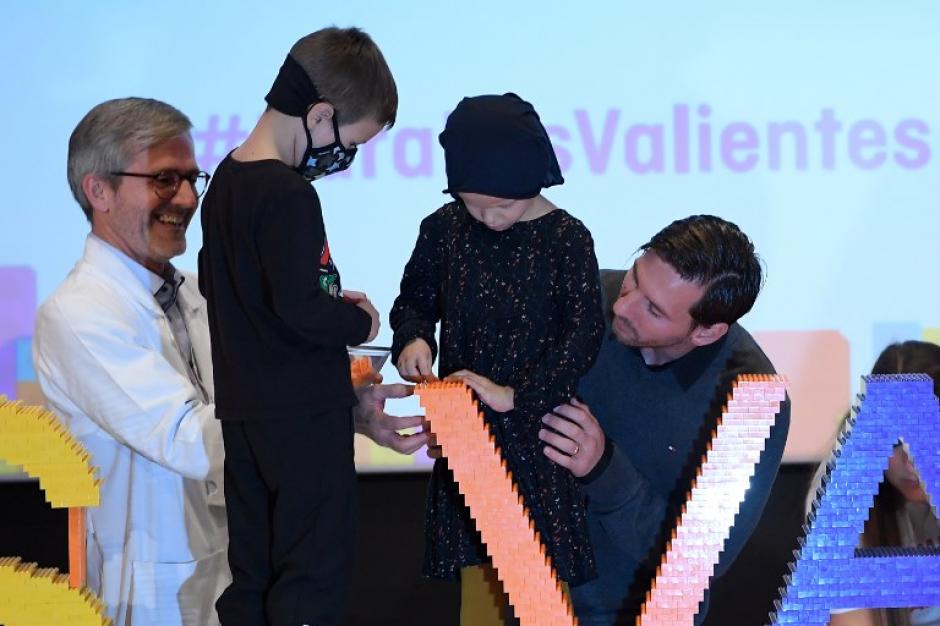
[199,155,371,420]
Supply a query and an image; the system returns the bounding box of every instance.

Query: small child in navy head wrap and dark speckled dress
[391,94,604,624]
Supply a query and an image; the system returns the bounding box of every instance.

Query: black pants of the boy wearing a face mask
[216,409,357,626]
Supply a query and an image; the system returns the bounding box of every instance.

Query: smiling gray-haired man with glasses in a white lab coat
[33,98,426,626]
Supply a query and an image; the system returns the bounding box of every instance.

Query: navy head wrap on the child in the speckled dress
[439,93,565,200]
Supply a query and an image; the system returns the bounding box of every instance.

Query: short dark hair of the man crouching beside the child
[640,215,763,326]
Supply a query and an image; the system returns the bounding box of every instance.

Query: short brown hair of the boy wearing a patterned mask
[290,26,398,128]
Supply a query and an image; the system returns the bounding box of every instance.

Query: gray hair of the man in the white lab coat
[68,98,193,222]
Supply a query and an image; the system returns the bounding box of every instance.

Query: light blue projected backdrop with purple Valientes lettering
[0,0,940,469]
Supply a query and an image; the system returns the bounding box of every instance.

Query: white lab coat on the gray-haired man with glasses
[33,235,231,626]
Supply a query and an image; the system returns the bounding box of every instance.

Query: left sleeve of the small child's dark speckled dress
[389,211,444,363]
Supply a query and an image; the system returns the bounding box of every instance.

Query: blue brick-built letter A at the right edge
[771,374,940,626]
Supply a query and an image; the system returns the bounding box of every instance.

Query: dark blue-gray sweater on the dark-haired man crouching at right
[572,270,790,626]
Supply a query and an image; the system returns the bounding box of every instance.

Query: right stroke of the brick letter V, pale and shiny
[637,375,786,626]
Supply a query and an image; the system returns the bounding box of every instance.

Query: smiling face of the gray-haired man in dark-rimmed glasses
[85,133,199,274]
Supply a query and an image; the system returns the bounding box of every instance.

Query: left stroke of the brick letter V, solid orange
[415,382,577,626]
